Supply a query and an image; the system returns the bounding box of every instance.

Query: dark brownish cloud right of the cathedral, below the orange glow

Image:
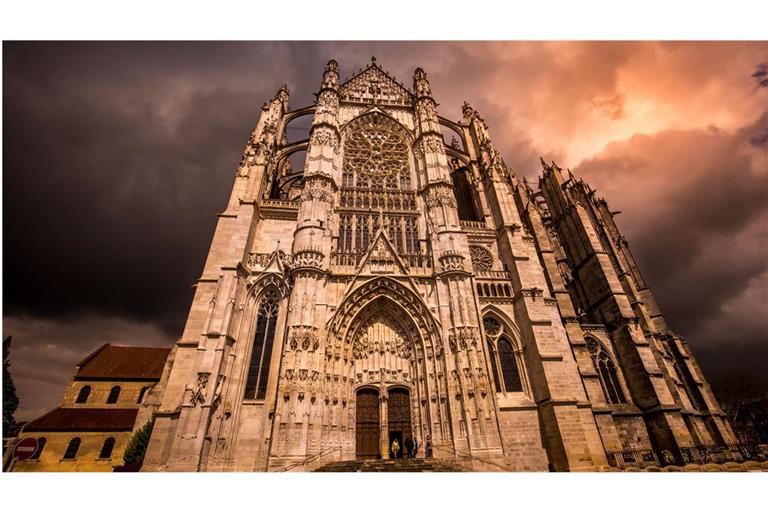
[574,113,768,371]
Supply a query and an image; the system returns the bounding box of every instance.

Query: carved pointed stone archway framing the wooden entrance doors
[326,277,450,458]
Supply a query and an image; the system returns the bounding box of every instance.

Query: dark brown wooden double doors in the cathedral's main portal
[355,388,412,458]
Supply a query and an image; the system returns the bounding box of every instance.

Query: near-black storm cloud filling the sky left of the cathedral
[4,44,322,331]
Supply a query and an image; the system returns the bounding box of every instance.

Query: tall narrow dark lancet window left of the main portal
[245,288,280,400]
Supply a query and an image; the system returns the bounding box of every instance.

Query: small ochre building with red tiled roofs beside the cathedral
[13,344,170,472]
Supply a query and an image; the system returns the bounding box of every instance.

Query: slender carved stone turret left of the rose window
[273,60,340,458]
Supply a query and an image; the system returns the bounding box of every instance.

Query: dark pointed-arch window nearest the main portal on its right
[483,316,524,393]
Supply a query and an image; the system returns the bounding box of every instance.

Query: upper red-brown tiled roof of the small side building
[75,344,171,380]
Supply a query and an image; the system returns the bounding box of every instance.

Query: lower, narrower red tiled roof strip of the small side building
[24,407,139,432]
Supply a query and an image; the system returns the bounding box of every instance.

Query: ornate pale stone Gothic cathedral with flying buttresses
[143,60,736,471]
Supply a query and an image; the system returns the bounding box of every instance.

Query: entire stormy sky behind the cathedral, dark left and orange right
[3,42,768,419]
